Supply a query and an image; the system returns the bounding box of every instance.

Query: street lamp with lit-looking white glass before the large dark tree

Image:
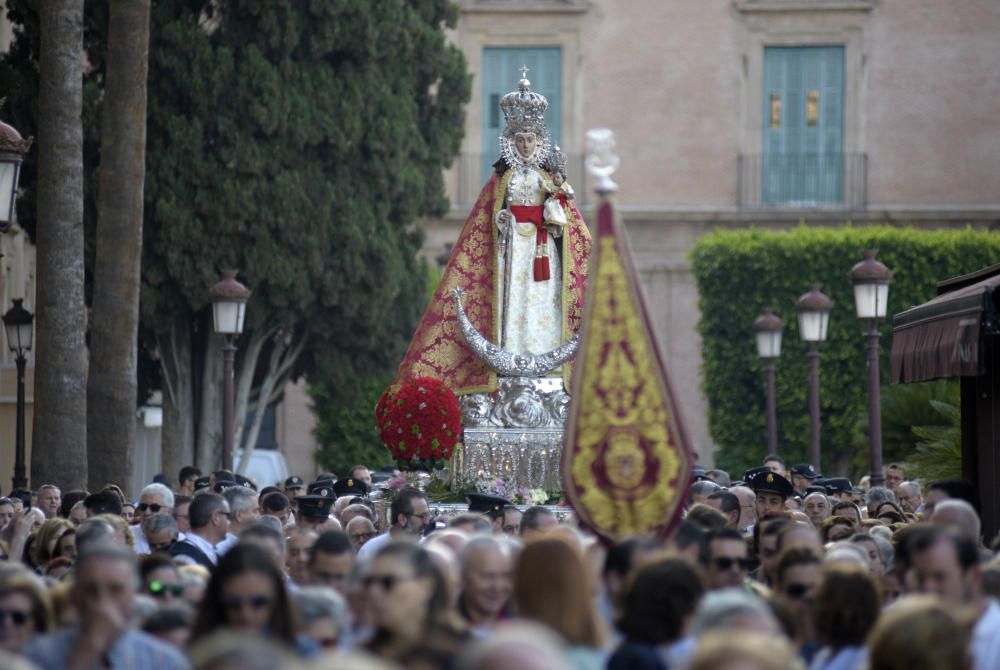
[209,270,250,470]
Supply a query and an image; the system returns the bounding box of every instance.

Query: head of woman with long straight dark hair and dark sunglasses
[191,544,298,649]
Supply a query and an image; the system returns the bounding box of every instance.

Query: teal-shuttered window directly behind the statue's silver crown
[479,47,562,183]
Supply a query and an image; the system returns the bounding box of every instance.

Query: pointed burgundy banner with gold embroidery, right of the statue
[562,193,691,542]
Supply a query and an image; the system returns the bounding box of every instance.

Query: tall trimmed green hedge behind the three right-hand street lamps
[692,225,1000,476]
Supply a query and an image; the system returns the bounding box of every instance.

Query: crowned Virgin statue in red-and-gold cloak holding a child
[397,69,590,395]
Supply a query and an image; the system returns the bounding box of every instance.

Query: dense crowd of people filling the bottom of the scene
[0,456,1000,670]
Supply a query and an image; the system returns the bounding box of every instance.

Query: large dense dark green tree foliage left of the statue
[0,0,470,470]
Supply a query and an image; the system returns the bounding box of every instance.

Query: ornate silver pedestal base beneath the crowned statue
[452,377,569,492]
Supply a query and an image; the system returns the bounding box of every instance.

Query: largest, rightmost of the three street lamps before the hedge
[851,249,892,486]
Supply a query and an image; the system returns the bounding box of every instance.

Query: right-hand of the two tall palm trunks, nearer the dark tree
[87,0,150,490]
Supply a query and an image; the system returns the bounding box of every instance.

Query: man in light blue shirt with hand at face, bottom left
[25,544,190,670]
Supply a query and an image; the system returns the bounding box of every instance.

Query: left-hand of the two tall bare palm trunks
[31,0,87,490]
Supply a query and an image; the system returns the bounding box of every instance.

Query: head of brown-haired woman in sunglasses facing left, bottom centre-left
[361,542,468,668]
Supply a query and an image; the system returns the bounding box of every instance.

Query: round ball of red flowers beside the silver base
[375,377,462,470]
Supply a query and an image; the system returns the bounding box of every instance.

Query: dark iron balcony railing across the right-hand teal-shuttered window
[738,153,868,208]
